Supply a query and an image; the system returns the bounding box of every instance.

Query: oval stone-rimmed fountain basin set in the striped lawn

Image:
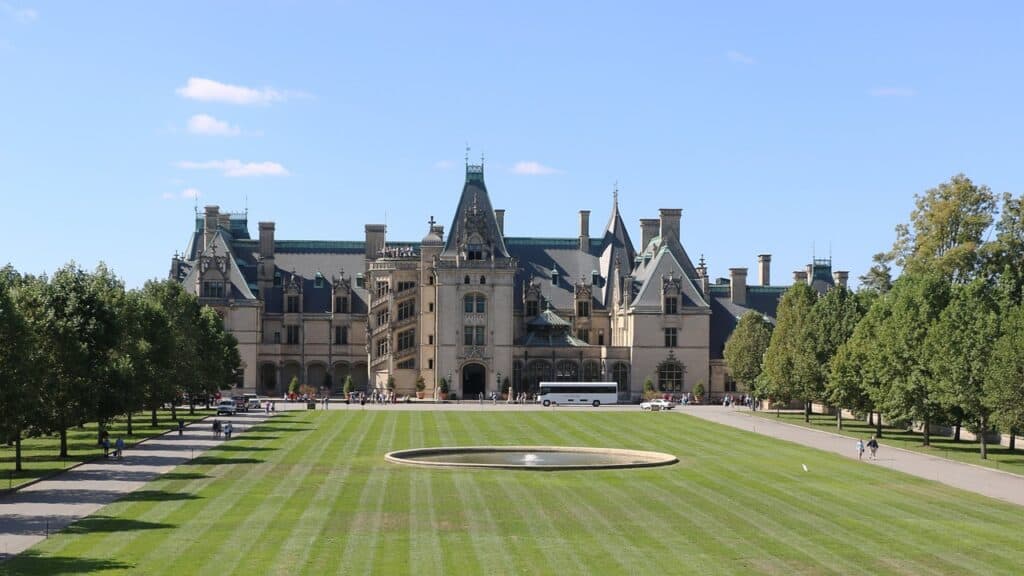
[385,446,679,470]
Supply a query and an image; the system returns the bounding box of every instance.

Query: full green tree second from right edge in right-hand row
[926,278,998,459]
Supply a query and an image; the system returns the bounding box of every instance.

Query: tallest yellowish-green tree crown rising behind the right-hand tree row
[892,174,995,283]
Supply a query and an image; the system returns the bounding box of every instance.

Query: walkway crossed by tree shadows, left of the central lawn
[0,412,267,562]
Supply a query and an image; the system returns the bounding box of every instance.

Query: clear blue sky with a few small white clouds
[0,0,1024,286]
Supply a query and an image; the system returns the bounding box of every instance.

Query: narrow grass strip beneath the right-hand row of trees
[755,410,1024,475]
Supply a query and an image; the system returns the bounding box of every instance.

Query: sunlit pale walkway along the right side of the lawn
[677,406,1024,505]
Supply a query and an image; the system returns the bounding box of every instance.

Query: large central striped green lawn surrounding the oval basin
[8,410,1024,576]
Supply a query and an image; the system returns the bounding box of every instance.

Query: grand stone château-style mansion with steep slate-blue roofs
[170,165,848,401]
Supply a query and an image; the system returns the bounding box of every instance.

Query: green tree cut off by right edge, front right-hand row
[984,305,1024,448]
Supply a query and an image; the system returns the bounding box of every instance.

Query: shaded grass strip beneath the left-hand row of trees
[0,407,214,487]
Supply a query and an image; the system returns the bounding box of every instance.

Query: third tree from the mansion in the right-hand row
[802,286,863,428]
